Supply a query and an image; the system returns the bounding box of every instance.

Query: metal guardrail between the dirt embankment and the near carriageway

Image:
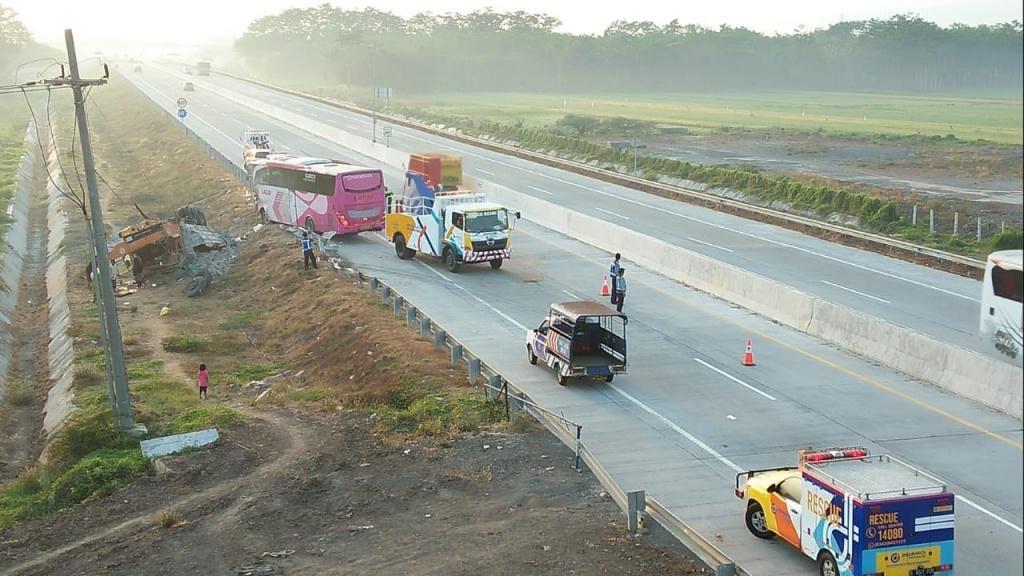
[132,91,749,576]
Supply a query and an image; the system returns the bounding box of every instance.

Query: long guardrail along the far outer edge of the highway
[217,71,985,276]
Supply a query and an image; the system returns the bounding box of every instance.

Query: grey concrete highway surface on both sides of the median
[121,66,1024,576]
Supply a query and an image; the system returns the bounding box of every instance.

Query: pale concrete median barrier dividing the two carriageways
[159,68,1024,419]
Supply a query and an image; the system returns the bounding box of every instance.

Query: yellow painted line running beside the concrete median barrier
[516,230,1024,450]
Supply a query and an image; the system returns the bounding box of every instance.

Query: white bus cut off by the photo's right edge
[981,250,1024,365]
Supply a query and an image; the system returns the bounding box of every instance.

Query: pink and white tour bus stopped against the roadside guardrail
[247,154,387,235]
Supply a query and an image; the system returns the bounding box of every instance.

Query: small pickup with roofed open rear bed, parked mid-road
[526,301,628,385]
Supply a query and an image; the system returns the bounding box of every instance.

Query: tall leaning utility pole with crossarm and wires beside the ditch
[61,29,135,429]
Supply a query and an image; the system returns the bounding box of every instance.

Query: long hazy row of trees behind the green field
[236,4,1024,92]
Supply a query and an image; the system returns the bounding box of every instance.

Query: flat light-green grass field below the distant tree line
[395,91,1024,145]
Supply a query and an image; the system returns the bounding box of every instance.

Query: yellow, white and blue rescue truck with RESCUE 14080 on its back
[736,447,955,576]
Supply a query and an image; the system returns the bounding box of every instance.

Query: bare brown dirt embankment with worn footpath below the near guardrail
[0,80,708,575]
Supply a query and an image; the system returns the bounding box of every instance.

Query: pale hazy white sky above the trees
[8,0,1024,49]
